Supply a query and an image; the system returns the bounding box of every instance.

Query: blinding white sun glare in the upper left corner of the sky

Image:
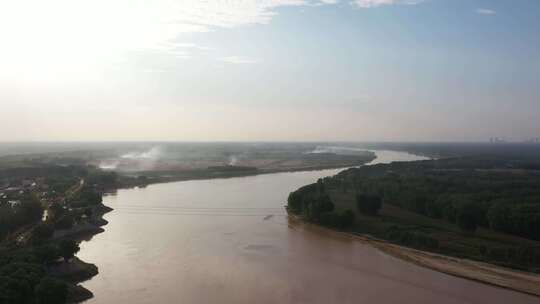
[0,0,186,82]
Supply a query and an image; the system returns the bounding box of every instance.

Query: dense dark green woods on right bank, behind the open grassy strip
[329,160,540,240]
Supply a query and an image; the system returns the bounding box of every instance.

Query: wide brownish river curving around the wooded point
[78,151,540,304]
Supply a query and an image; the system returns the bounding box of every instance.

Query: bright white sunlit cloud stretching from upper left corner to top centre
[0,0,335,66]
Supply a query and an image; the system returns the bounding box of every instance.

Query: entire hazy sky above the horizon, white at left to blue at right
[0,0,540,141]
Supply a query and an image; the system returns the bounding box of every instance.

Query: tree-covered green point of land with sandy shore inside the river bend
[286,153,540,295]
